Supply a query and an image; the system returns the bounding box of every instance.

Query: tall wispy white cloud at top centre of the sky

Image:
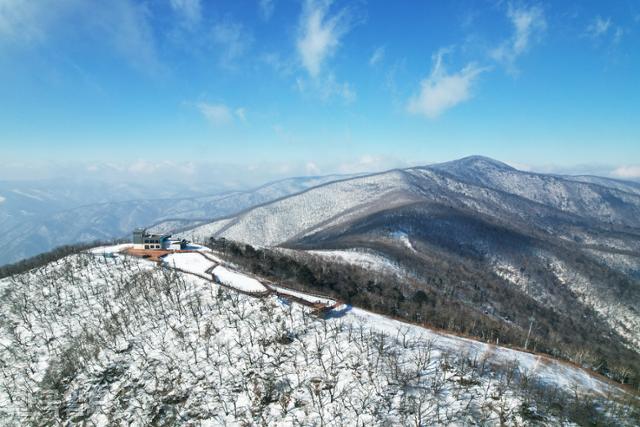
[296,0,349,77]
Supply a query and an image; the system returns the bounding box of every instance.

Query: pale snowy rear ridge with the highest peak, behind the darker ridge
[182,156,640,250]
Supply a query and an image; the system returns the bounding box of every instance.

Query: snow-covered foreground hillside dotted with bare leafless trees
[0,246,638,425]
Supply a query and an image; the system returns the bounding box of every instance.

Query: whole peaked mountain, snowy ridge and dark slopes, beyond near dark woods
[183,156,640,382]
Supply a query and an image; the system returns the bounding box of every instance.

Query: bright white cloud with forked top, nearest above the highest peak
[407,50,486,119]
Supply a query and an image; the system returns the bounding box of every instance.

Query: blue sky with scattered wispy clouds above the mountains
[0,0,640,184]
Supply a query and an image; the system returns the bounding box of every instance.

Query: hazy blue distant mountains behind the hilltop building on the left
[0,176,350,265]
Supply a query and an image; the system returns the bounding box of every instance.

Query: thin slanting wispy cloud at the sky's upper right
[491,4,547,72]
